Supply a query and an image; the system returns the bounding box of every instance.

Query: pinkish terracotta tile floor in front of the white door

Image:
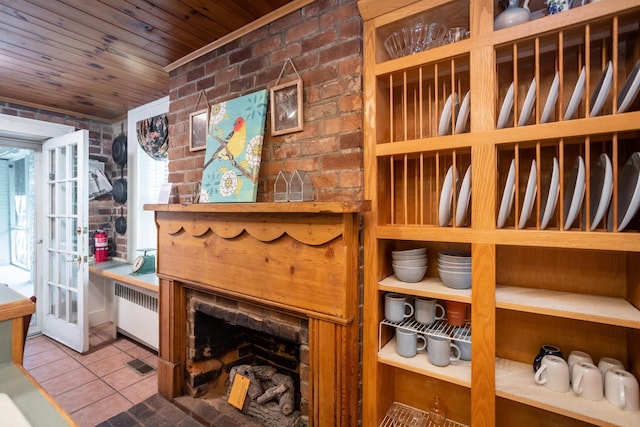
[24,324,158,427]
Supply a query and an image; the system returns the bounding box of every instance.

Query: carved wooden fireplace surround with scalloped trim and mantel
[145,202,369,426]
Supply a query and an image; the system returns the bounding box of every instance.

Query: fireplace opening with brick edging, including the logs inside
[186,295,308,427]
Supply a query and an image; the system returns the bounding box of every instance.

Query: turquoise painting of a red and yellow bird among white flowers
[200,89,267,203]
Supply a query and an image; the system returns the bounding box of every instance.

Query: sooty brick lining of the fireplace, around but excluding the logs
[185,291,309,425]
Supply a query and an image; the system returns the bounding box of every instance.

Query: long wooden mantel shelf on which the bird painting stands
[144,200,371,214]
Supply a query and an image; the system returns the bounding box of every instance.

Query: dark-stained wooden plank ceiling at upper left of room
[0,0,291,122]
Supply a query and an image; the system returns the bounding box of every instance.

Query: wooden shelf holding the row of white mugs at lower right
[496,358,640,427]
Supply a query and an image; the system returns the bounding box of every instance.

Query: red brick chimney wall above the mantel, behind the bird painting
[169,0,363,202]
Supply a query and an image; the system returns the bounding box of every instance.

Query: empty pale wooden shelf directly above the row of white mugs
[496,285,640,329]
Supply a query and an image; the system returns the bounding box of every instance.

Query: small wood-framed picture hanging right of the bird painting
[269,79,302,136]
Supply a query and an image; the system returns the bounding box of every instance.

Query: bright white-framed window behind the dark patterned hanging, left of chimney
[127,96,169,260]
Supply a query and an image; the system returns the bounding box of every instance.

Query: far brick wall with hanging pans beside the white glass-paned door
[0,101,127,258]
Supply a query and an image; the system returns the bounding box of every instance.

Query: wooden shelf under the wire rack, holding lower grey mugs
[378,338,471,387]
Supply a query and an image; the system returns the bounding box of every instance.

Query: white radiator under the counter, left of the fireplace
[114,282,160,350]
